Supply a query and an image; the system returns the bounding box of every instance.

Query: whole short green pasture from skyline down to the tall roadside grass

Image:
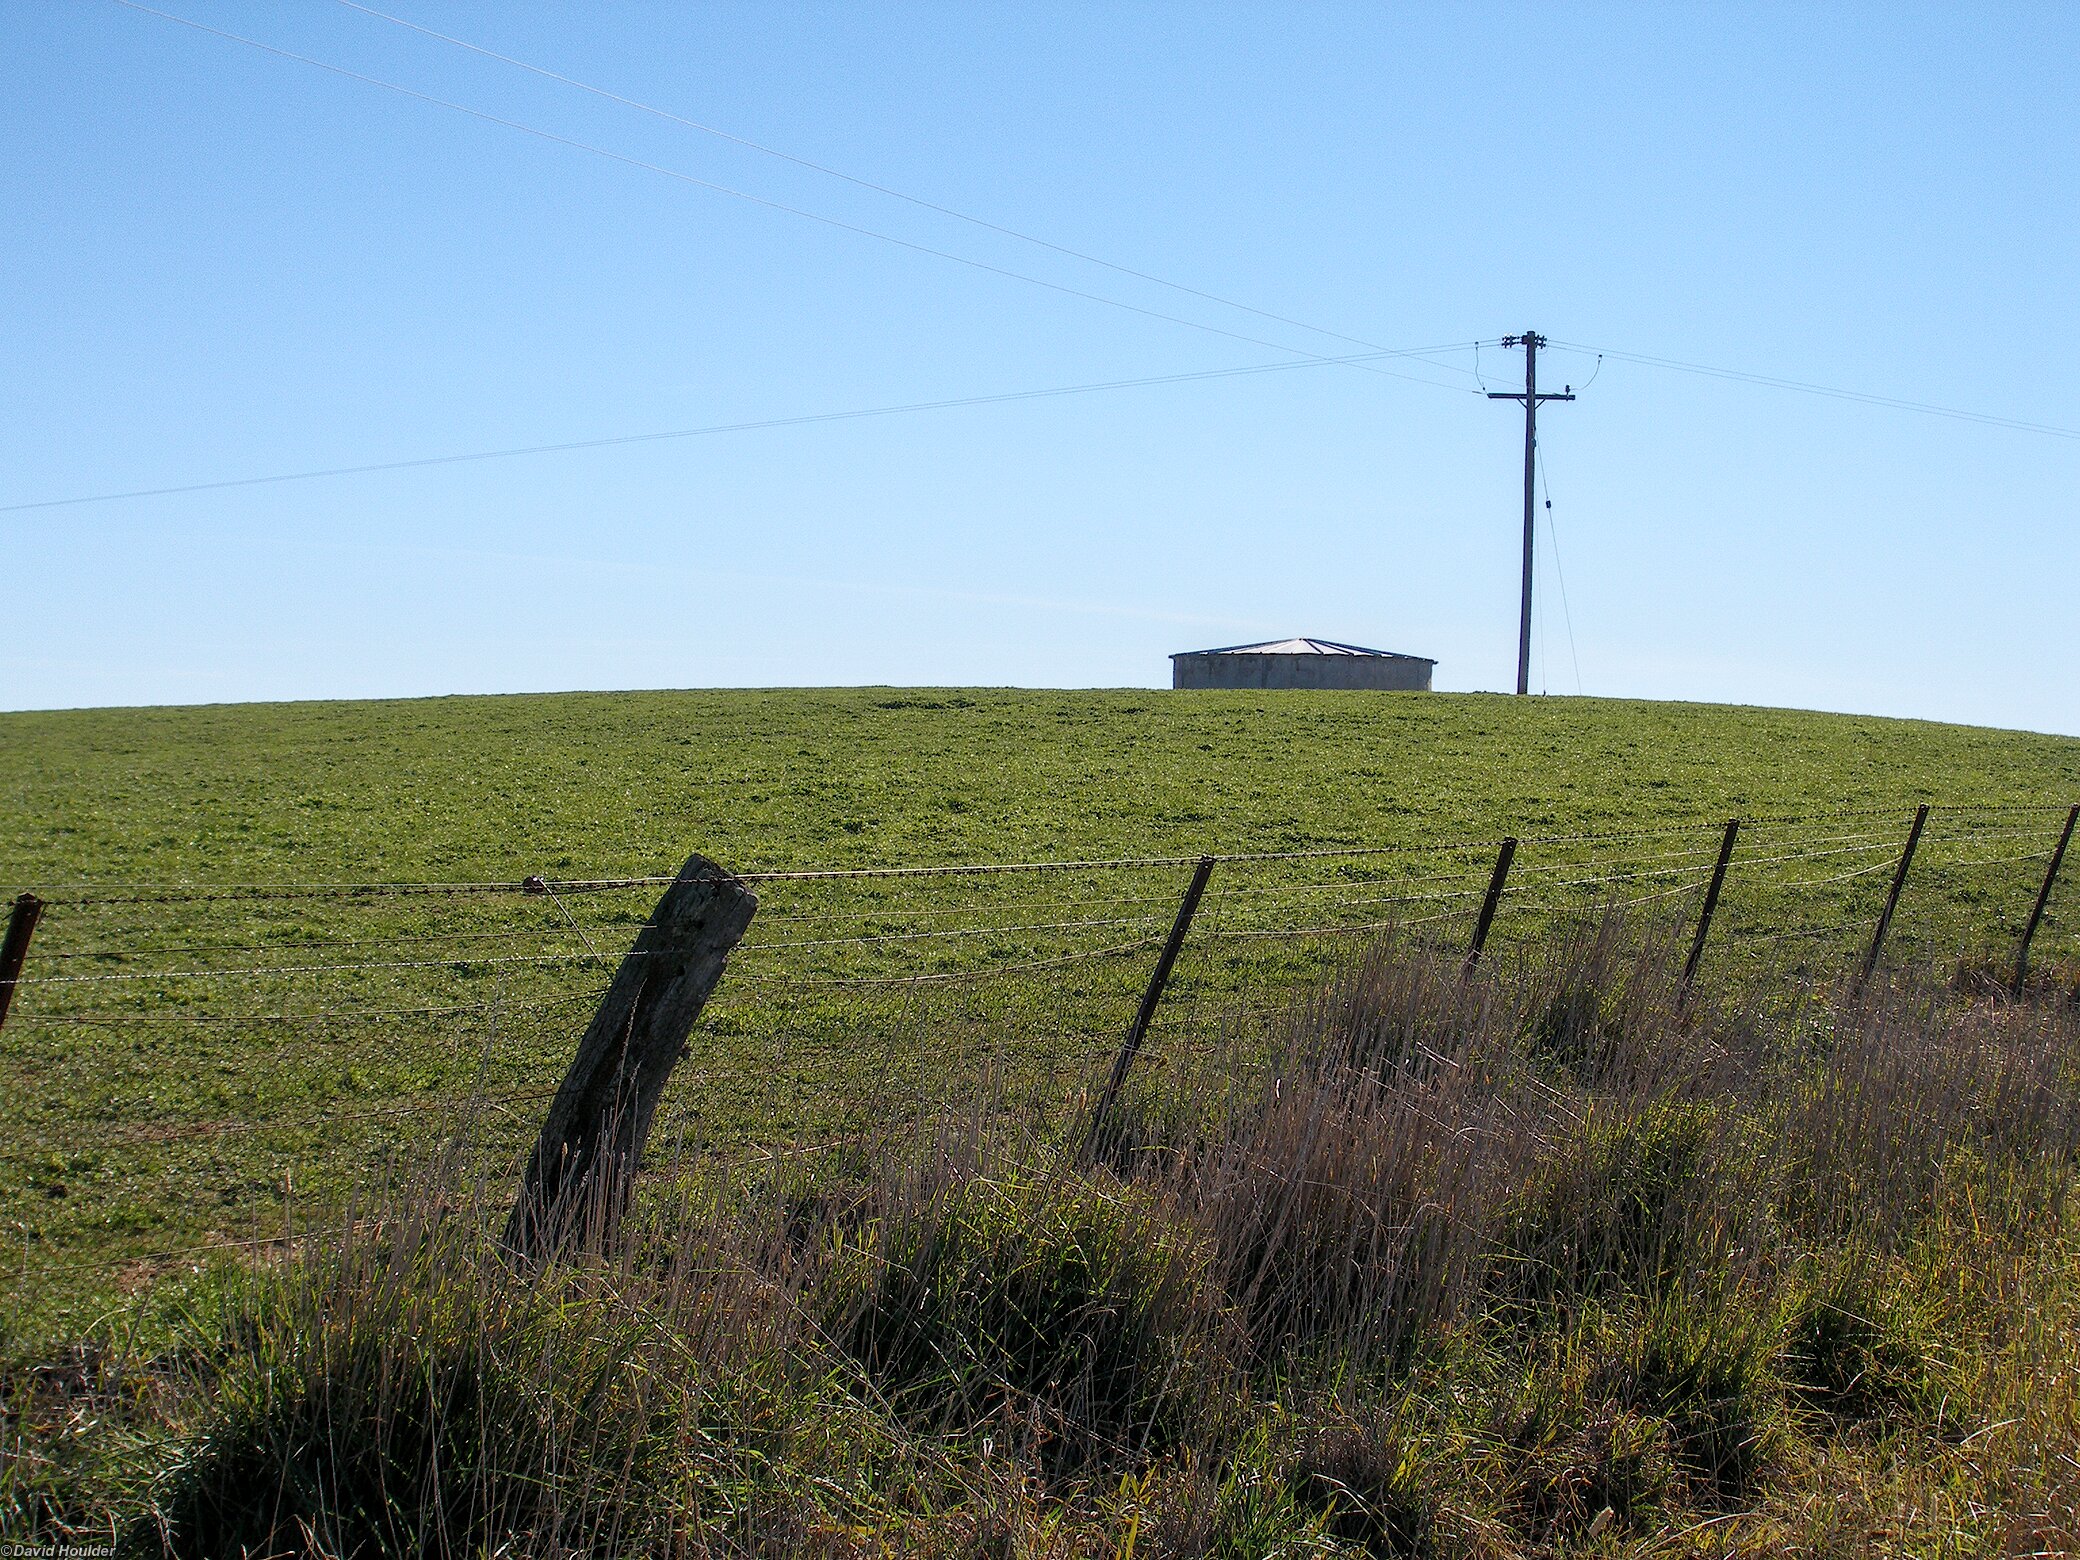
[0,688,2080,1327]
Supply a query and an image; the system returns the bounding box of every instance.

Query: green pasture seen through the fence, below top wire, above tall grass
[0,803,2080,1315]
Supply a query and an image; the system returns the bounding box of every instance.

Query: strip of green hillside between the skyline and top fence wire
[0,688,2080,886]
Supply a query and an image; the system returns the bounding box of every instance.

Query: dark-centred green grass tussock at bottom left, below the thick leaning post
[133,1238,686,1556]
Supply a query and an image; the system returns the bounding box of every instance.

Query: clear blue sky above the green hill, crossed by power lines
[0,0,2080,732]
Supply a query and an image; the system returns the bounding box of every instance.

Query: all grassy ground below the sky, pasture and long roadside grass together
[12,688,2080,1558]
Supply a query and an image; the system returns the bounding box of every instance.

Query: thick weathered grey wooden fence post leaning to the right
[505,855,759,1263]
